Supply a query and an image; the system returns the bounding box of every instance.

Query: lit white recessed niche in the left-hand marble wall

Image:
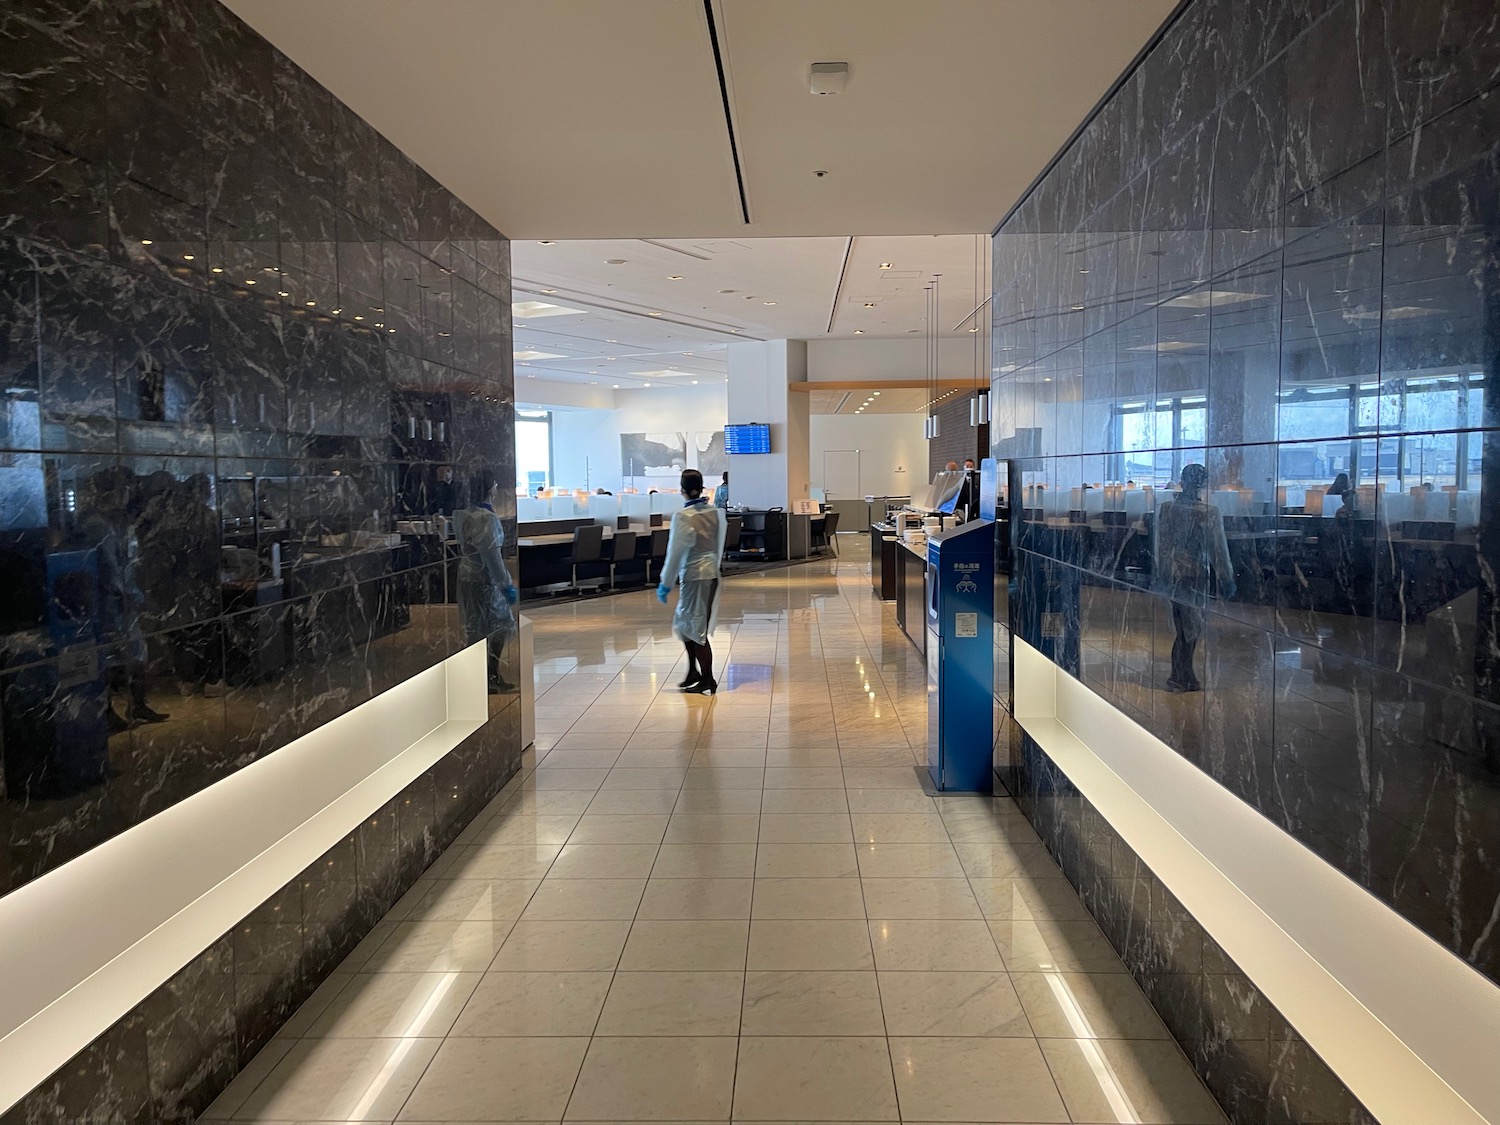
[0,642,489,1113]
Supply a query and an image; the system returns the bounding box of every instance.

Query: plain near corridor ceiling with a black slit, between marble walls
[227,0,1175,238]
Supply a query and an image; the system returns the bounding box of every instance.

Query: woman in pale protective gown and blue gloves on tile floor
[657,470,726,696]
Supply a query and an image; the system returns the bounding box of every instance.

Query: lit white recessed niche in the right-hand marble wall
[1014,638,1500,1125]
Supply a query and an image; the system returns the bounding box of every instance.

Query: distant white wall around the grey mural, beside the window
[552,383,728,492]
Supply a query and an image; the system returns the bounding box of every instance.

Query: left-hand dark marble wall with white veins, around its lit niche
[0,0,519,1121]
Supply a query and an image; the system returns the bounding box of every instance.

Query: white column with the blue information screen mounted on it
[726,341,810,509]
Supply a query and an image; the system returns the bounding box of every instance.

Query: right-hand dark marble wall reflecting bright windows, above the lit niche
[993,0,1500,1119]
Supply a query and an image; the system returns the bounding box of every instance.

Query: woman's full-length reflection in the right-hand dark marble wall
[1154,465,1235,692]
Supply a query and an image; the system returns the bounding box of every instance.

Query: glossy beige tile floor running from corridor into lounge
[207,551,1223,1125]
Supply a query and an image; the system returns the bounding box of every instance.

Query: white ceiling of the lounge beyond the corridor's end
[512,234,989,395]
